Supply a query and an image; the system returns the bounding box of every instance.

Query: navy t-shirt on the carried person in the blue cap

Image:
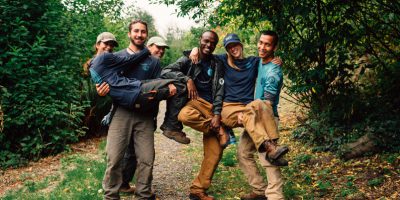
[217,54,259,104]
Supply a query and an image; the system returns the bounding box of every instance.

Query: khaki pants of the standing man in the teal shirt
[237,117,284,200]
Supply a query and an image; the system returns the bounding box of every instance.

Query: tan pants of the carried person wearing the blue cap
[221,99,279,149]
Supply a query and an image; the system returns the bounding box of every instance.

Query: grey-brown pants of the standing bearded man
[103,106,155,199]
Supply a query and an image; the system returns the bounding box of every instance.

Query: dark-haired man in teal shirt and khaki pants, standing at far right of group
[238,31,287,200]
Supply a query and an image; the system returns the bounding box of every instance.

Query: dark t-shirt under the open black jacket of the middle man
[194,60,213,103]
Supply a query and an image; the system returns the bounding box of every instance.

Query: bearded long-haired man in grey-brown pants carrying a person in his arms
[99,20,188,199]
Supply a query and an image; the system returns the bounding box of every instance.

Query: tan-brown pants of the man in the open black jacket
[178,98,223,193]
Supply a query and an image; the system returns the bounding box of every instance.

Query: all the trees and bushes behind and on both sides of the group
[0,0,400,168]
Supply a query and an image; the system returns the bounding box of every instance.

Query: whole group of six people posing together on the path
[89,20,289,200]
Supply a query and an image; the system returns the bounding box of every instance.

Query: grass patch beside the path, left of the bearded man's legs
[2,141,106,200]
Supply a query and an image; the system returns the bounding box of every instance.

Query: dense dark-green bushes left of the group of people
[0,0,120,167]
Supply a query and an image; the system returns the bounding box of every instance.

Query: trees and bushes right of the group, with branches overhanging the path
[159,0,400,152]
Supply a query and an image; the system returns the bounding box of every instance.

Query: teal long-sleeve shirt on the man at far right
[254,60,283,117]
